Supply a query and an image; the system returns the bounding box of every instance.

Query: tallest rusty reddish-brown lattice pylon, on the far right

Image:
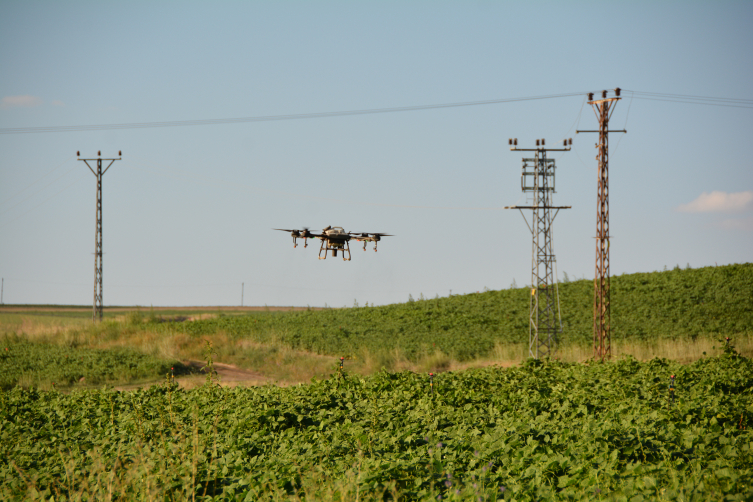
[575,87,627,361]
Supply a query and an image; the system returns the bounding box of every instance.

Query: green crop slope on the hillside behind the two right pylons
[169,264,753,360]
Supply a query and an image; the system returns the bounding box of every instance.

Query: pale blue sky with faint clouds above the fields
[0,0,753,306]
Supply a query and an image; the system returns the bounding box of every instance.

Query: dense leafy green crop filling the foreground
[0,349,753,501]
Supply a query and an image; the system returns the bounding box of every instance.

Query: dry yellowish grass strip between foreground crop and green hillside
[0,311,753,387]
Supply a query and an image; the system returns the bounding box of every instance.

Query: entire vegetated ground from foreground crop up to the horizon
[0,264,753,501]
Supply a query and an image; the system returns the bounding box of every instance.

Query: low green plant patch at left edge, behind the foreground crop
[0,336,187,389]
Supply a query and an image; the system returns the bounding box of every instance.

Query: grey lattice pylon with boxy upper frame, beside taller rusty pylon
[505,138,573,359]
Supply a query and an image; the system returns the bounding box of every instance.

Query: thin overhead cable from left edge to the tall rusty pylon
[0,92,585,134]
